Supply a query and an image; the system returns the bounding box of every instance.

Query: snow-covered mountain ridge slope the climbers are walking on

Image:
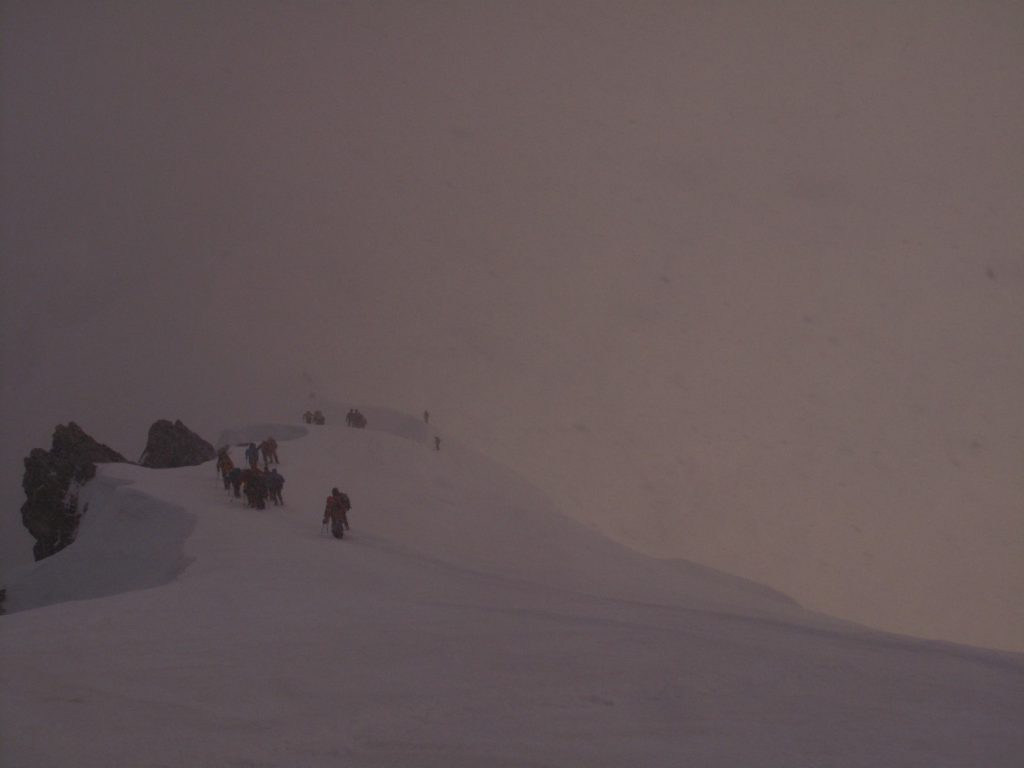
[0,421,1024,768]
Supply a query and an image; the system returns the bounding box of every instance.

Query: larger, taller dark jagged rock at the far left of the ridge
[22,422,127,560]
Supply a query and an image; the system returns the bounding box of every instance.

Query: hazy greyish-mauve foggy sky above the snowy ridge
[0,2,1024,649]
